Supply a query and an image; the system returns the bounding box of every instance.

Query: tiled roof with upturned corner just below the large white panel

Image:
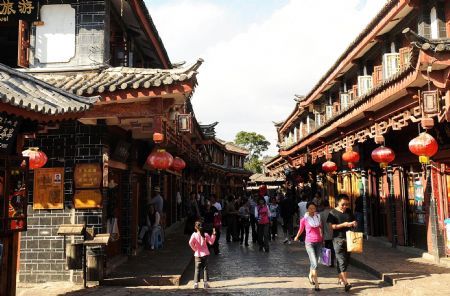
[30,59,203,96]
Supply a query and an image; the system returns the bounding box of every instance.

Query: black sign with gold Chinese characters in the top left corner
[0,0,40,23]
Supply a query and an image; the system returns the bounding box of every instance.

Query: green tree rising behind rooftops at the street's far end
[234,131,270,173]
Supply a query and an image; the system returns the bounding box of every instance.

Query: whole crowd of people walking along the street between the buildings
[185,187,362,291]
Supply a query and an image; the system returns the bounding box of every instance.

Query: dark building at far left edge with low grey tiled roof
[0,64,96,296]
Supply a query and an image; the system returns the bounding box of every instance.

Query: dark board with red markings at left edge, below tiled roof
[0,156,28,235]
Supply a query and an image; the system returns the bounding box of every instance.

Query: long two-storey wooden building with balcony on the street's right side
[267,0,450,258]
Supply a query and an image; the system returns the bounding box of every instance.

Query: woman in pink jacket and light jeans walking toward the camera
[295,202,323,291]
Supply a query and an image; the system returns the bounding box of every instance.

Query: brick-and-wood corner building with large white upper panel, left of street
[0,0,250,286]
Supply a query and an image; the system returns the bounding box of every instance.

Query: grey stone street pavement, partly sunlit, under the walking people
[18,234,448,296]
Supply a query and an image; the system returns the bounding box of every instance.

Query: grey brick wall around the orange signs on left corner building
[19,122,106,282]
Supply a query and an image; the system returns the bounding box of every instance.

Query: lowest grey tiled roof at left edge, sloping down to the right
[0,64,98,115]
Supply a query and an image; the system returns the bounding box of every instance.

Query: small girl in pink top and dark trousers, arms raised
[189,221,216,289]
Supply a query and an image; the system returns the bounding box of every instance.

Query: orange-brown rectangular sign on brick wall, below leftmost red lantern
[33,168,64,210]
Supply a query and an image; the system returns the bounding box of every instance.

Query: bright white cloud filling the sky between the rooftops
[150,0,385,154]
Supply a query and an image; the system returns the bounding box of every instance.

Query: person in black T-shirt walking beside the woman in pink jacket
[327,194,357,292]
